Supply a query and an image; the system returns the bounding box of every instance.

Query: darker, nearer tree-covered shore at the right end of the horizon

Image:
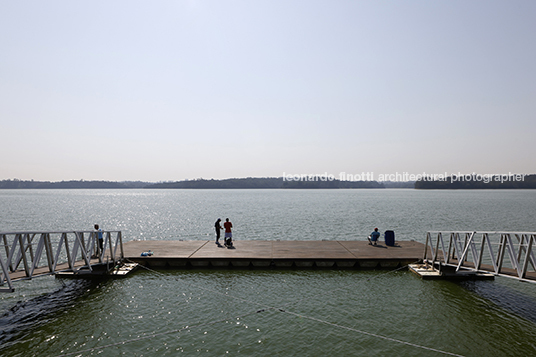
[415,174,536,190]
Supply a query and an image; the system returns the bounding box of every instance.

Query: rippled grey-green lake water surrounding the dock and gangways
[0,190,536,356]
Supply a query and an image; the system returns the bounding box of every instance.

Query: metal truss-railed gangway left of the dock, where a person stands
[0,231,124,292]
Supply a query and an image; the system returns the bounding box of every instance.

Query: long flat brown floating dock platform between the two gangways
[123,240,425,268]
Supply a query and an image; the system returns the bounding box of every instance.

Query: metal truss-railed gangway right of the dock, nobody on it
[423,231,536,283]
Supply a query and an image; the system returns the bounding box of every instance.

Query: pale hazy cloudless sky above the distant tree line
[0,0,536,181]
